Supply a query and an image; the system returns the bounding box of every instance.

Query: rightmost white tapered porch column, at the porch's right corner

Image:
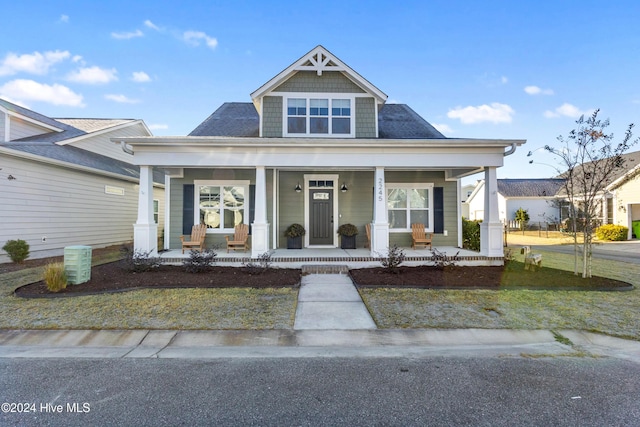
[480,167,504,257]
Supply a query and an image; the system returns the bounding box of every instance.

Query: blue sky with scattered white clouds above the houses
[0,0,640,178]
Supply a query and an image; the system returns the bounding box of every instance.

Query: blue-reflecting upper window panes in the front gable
[286,98,353,136]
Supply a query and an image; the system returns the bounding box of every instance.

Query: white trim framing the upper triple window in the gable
[279,92,356,138]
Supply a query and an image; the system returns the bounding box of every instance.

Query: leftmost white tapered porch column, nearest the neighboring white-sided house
[133,166,158,256]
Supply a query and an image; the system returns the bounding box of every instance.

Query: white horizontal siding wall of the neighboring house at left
[0,156,164,262]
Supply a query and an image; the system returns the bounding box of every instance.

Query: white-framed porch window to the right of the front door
[387,184,433,231]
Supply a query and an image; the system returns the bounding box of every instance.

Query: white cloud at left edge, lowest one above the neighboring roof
[0,79,84,107]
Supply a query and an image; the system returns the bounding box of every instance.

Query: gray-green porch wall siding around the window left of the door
[167,169,274,252]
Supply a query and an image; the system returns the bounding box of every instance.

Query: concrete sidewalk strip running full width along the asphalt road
[0,329,640,363]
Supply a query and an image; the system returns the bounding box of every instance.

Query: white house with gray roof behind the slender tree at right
[467,178,564,224]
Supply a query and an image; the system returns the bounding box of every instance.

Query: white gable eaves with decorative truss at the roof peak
[251,45,387,106]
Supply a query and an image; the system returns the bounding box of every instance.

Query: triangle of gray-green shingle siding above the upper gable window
[274,71,364,93]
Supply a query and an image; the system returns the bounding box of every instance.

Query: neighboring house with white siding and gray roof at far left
[0,99,164,262]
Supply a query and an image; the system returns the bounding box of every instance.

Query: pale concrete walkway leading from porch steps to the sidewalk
[293,274,376,330]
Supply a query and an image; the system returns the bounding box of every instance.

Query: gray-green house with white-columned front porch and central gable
[113,46,525,257]
